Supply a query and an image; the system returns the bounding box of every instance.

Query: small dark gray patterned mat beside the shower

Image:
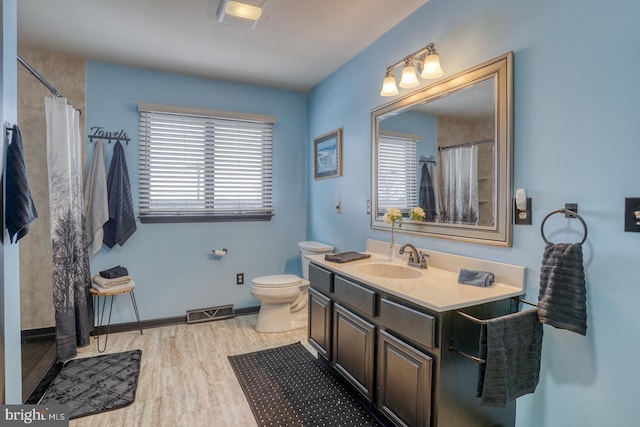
[40,350,142,419]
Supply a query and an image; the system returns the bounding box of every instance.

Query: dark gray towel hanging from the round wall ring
[538,243,587,335]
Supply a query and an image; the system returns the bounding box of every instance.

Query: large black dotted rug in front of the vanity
[229,343,383,427]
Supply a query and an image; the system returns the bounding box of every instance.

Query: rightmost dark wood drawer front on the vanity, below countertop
[380,298,436,348]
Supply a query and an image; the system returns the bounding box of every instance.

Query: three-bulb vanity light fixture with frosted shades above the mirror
[380,43,444,96]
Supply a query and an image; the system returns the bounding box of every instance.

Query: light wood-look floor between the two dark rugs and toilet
[70,315,316,427]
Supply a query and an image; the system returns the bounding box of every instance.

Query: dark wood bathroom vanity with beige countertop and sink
[308,241,524,427]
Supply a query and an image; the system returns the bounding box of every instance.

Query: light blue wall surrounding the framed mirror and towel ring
[307,0,640,427]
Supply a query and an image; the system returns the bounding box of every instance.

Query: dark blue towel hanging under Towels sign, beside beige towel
[103,141,136,248]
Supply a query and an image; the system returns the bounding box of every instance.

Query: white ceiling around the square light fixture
[18,0,428,92]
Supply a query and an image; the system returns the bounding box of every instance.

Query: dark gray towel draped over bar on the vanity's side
[477,310,542,408]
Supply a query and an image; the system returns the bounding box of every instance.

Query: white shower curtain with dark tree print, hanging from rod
[45,97,93,361]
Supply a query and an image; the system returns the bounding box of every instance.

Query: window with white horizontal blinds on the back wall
[139,104,275,222]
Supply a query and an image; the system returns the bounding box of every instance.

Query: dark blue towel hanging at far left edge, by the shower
[5,125,38,243]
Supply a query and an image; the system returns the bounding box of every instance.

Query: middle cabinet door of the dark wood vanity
[332,304,376,401]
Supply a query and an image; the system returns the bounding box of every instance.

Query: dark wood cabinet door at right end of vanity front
[377,331,433,427]
